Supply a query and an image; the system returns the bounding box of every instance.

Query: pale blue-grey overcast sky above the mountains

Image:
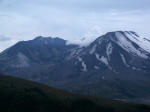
[0,0,150,51]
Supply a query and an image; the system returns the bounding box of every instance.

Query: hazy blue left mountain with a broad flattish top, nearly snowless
[0,36,77,80]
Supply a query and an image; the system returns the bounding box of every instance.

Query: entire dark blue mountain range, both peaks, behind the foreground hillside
[0,31,150,102]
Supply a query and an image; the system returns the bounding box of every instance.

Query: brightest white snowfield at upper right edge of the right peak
[125,32,150,53]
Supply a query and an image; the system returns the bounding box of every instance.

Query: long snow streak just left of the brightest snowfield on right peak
[115,32,148,59]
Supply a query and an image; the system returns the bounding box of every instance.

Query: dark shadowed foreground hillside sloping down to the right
[0,76,150,112]
